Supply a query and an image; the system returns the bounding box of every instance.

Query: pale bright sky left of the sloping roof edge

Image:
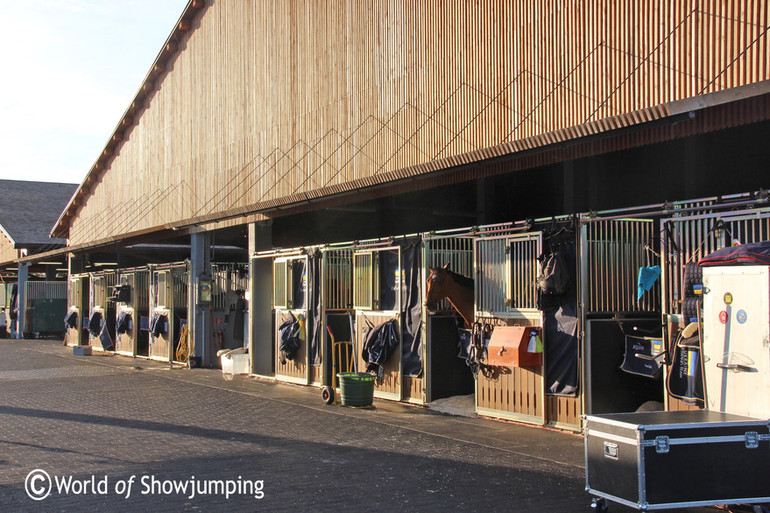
[0,0,187,184]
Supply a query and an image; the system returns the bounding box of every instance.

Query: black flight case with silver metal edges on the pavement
[585,410,770,510]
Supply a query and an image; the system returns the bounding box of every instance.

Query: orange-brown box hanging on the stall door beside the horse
[487,326,543,367]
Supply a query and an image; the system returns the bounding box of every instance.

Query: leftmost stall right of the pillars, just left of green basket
[251,244,353,386]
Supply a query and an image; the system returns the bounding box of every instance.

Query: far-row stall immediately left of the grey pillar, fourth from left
[148,262,190,362]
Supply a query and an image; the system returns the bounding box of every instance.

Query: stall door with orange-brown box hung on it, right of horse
[475,230,547,424]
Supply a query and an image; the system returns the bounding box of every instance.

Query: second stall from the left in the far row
[88,270,118,351]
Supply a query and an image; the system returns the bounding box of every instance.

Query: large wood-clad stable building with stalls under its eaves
[19,0,770,428]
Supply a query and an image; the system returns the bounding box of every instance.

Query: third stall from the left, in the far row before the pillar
[113,267,150,357]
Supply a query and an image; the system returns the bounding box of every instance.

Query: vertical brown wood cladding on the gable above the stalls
[69,0,770,244]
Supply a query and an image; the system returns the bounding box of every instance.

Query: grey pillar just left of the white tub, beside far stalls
[187,232,216,367]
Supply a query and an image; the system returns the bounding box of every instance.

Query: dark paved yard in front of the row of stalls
[0,340,756,512]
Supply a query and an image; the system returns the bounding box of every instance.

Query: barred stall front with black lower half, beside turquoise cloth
[579,217,666,414]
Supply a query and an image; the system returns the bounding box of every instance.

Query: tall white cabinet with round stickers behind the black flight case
[703,265,770,419]
